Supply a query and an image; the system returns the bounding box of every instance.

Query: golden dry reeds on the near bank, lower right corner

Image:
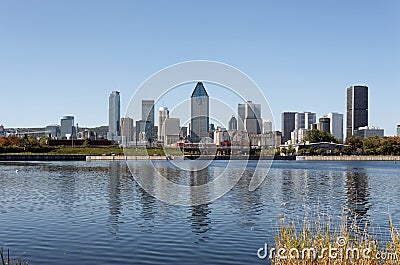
[269,213,400,265]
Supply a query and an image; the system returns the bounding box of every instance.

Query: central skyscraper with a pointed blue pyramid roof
[190,82,210,143]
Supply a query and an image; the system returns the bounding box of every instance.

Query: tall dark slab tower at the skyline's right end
[346,86,368,137]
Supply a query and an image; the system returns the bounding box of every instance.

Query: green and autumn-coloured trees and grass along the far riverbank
[0,130,400,156]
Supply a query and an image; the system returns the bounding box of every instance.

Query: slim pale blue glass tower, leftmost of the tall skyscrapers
[107,91,121,141]
